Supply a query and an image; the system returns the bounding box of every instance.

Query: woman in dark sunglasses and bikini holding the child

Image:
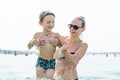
[54,17,88,80]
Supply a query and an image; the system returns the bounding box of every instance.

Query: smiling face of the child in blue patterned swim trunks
[40,15,55,32]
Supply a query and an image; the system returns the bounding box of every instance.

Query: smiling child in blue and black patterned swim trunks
[28,11,61,80]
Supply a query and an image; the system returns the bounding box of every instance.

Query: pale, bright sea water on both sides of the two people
[0,54,120,80]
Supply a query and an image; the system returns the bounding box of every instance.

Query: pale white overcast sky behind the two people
[0,0,120,52]
